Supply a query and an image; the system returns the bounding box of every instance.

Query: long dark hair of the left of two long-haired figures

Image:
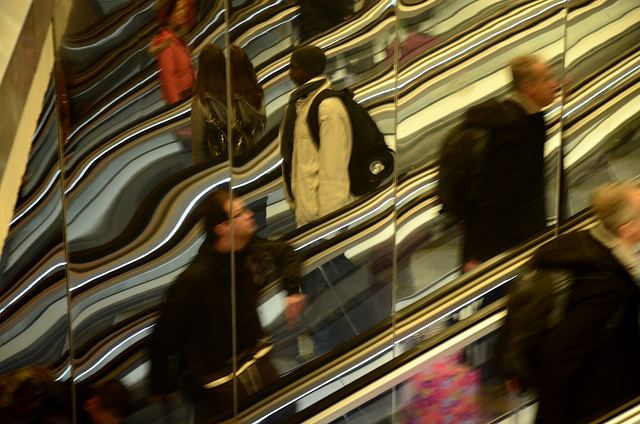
[193,44,227,104]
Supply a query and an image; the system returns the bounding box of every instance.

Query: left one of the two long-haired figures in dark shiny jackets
[191,44,227,164]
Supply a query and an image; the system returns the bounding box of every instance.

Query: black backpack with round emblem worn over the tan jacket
[307,89,394,196]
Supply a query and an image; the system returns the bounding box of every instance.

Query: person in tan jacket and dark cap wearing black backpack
[280,46,394,227]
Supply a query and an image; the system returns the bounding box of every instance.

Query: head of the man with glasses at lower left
[198,190,257,253]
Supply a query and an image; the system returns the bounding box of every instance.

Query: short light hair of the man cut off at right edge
[591,181,640,232]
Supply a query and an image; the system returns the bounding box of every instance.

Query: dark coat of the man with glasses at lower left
[149,239,300,394]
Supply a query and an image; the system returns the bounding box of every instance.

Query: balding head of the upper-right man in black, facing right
[511,55,558,109]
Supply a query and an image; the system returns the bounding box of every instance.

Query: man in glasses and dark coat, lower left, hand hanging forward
[149,191,305,423]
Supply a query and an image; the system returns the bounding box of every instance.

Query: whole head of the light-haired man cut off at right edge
[592,182,640,246]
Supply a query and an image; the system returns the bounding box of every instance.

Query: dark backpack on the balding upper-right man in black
[437,123,491,221]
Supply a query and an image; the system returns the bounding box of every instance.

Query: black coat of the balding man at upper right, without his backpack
[463,99,546,261]
